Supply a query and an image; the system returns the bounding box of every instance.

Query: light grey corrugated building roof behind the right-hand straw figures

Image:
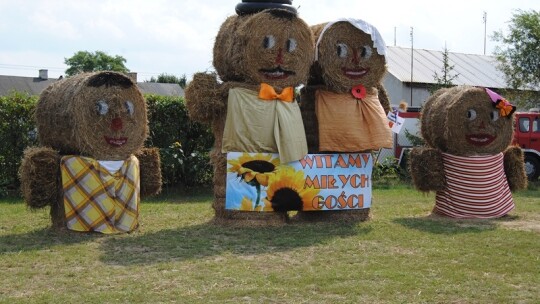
[386,46,508,89]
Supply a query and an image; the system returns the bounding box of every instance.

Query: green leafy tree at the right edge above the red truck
[492,10,540,106]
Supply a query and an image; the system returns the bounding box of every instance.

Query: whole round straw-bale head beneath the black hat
[213,9,314,87]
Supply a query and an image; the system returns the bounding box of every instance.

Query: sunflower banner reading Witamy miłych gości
[225,152,373,212]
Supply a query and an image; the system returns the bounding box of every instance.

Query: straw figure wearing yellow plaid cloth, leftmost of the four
[20,72,161,234]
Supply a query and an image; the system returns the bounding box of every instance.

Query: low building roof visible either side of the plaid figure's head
[0,70,184,97]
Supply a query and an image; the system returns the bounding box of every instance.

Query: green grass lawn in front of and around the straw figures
[0,186,540,303]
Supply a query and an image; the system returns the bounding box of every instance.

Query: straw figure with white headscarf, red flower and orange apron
[298,19,392,220]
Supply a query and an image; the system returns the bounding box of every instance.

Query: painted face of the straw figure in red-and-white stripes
[447,88,513,155]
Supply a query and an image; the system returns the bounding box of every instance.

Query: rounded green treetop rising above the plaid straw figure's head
[64,51,129,76]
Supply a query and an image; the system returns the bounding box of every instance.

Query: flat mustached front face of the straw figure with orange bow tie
[239,11,314,87]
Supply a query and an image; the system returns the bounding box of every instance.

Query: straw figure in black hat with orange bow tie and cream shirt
[186,1,314,225]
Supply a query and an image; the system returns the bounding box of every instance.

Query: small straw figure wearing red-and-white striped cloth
[410,86,527,218]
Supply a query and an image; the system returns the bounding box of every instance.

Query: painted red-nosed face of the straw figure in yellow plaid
[77,86,147,160]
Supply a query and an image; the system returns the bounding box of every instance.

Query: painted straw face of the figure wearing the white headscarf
[318,22,386,92]
